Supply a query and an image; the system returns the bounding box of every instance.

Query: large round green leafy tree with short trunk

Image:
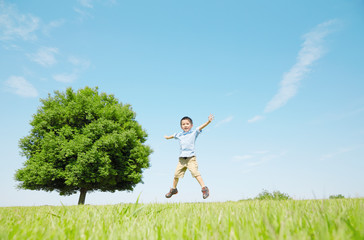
[15,87,152,204]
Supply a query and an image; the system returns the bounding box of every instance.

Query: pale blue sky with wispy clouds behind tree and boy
[0,0,364,206]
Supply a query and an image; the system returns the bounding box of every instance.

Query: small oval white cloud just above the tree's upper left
[5,76,38,97]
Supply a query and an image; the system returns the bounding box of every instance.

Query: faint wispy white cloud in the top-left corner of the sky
[0,1,40,40]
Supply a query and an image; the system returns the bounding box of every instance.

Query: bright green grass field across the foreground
[0,199,364,239]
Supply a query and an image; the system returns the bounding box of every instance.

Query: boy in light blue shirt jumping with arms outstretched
[164,114,214,199]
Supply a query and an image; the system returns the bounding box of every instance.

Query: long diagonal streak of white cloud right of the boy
[264,20,336,113]
